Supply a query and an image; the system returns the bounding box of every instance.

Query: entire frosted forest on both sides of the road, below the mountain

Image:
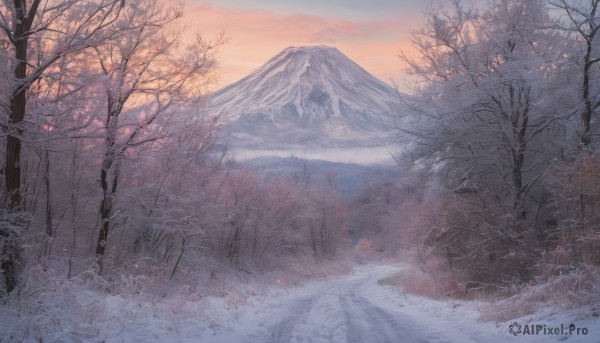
[0,0,600,341]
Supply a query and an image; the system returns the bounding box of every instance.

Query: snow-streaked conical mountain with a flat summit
[208,46,398,148]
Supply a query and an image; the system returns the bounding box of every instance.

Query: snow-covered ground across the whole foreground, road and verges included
[0,265,600,343]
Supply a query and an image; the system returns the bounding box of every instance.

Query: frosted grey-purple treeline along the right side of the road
[397,0,600,290]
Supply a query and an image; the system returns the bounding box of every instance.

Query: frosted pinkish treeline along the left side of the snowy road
[0,0,346,293]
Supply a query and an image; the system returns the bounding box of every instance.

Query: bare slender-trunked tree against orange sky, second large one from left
[95,0,223,272]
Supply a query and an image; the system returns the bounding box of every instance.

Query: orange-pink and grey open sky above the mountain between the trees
[186,0,430,87]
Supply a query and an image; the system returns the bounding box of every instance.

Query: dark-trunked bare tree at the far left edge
[0,0,119,292]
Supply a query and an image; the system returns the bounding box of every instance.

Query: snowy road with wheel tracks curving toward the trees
[192,266,514,343]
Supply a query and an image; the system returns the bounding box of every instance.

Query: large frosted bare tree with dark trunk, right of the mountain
[399,0,569,220]
